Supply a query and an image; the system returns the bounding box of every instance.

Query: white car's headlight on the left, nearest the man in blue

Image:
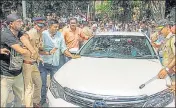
[49,77,64,98]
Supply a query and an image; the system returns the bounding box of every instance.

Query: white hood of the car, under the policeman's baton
[54,57,170,96]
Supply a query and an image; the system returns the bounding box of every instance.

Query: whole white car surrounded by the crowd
[47,32,175,107]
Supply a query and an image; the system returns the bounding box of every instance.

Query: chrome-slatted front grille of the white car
[64,87,148,107]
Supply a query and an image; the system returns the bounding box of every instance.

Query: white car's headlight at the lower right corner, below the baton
[143,89,174,107]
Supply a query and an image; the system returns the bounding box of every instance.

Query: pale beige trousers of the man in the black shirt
[1,73,24,107]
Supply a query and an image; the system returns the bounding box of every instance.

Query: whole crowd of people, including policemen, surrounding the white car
[0,14,175,107]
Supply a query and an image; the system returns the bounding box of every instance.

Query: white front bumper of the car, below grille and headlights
[47,89,175,107]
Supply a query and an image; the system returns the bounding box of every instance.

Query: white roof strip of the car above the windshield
[95,32,145,37]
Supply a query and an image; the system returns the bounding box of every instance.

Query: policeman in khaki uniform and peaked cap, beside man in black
[21,18,45,107]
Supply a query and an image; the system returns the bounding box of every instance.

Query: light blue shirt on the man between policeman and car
[41,30,67,66]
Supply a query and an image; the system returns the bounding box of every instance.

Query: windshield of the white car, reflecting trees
[80,35,157,59]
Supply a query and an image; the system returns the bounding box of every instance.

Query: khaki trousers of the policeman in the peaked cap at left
[23,63,42,107]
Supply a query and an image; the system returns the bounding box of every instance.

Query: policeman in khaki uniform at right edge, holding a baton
[158,20,176,93]
